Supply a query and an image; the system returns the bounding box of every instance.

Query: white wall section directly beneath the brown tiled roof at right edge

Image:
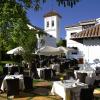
[83,38,100,63]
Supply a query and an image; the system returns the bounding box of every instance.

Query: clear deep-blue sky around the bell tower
[27,0,100,39]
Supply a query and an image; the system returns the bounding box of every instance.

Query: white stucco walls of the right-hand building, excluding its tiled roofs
[65,18,100,66]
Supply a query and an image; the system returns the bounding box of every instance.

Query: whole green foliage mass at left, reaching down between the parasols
[0,0,38,61]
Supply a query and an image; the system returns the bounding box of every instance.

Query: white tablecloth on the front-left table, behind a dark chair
[1,75,25,91]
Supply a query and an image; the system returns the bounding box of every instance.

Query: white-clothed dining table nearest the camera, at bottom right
[51,80,88,100]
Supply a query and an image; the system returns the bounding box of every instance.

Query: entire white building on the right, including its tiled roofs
[65,18,100,63]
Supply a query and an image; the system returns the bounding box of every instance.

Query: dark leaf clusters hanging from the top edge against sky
[18,0,80,10]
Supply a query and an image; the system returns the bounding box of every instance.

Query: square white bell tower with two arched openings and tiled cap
[44,11,61,40]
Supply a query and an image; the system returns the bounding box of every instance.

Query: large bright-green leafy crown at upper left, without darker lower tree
[0,1,28,50]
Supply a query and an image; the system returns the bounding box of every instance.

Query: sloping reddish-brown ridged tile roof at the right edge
[71,24,100,39]
